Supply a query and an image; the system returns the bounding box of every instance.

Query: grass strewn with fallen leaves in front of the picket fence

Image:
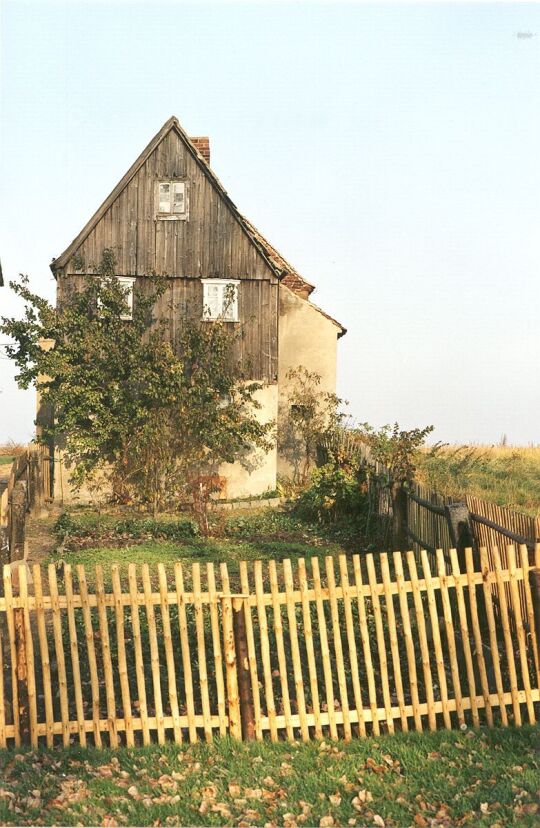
[0,727,539,828]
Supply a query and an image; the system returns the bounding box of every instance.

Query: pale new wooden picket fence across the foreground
[0,546,540,747]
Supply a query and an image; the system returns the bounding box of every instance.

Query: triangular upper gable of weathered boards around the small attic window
[60,130,274,279]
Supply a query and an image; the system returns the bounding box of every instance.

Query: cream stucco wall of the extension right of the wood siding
[277,285,340,477]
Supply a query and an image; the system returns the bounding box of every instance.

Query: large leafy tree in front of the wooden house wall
[1,250,272,524]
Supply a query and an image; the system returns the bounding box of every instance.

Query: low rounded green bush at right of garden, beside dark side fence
[295,463,366,523]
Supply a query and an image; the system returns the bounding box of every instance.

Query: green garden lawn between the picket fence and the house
[42,509,362,586]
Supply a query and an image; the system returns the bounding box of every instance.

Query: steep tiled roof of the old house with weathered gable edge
[51,116,346,337]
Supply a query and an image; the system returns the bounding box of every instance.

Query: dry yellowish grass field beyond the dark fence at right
[417,446,540,516]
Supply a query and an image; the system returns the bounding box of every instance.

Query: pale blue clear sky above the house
[0,0,540,445]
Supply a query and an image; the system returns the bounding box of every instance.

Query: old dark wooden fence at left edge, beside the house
[0,446,52,562]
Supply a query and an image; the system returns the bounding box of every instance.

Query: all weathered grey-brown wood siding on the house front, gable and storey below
[57,130,279,382]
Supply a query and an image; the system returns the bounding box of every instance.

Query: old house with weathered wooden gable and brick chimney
[51,117,345,497]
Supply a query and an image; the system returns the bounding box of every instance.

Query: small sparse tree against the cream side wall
[278,366,346,485]
